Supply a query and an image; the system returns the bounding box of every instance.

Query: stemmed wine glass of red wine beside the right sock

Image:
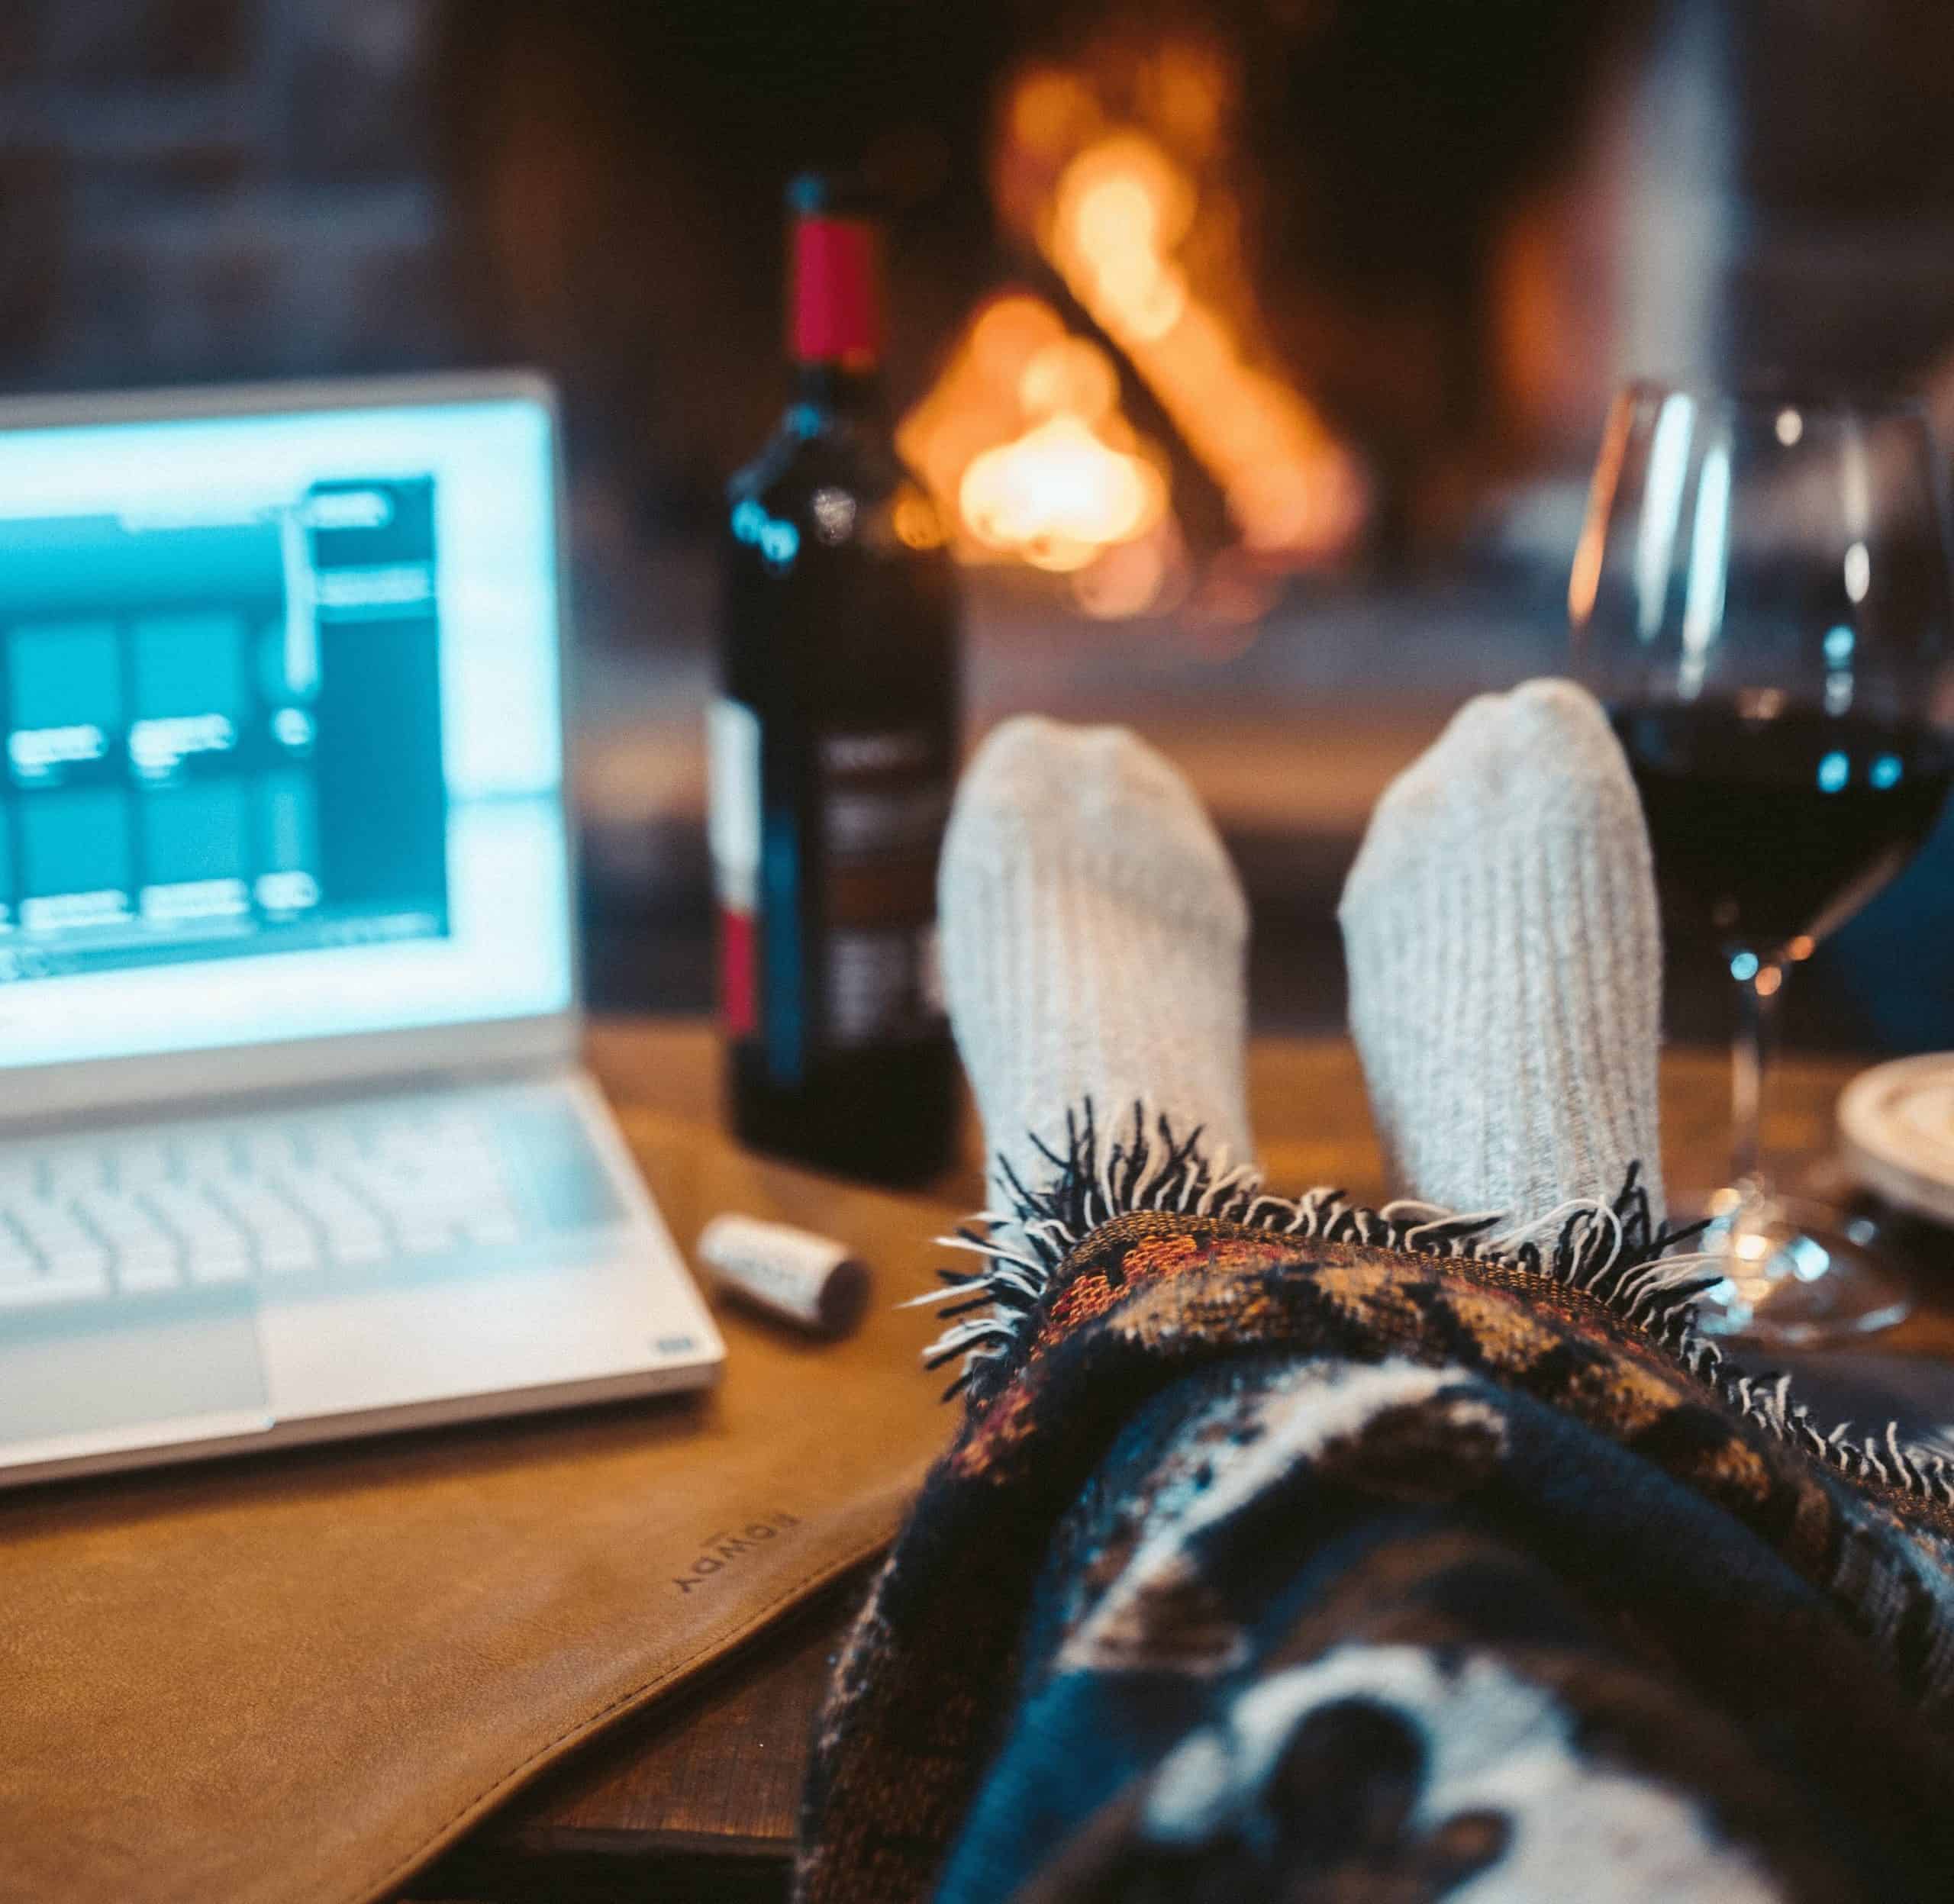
[1567,383,1954,1344]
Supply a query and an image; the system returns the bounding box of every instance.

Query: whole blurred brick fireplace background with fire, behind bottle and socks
[0,0,1954,1045]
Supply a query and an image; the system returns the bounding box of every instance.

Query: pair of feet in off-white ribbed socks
[940,681,1663,1224]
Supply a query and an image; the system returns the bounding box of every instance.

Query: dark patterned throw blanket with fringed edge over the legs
[799,1119,1954,1904]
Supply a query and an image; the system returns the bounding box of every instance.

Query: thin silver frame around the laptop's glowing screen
[0,369,584,1129]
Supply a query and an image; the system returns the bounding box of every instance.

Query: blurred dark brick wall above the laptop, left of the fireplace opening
[0,0,455,388]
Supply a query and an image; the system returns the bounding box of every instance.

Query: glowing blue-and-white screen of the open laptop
[0,396,572,1066]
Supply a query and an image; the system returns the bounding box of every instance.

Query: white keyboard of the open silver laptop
[0,1086,624,1313]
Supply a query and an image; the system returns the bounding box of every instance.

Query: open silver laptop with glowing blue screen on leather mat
[0,375,725,1486]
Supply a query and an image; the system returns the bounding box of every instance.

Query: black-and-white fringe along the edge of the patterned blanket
[904,1100,1954,1508]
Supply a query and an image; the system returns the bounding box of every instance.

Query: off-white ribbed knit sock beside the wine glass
[1339,681,1663,1220]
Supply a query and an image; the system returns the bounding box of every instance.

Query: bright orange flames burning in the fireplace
[903,47,1366,615]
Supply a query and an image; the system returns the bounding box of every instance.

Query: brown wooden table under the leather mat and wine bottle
[412,1020,1954,1904]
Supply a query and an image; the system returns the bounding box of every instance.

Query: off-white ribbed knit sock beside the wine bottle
[940,717,1249,1209]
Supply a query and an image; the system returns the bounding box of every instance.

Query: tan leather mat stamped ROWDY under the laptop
[0,1113,952,1904]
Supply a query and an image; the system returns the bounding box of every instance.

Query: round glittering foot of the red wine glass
[1694,1191,1913,1349]
